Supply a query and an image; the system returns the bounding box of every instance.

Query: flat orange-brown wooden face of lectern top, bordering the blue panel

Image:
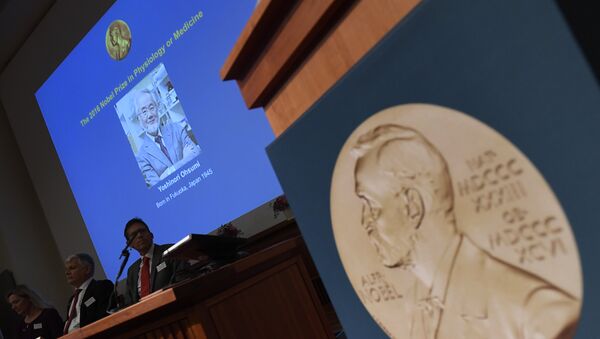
[265,0,420,135]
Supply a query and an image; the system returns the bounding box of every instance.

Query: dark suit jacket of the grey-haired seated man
[67,279,114,327]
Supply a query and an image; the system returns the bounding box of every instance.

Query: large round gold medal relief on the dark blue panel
[331,104,583,339]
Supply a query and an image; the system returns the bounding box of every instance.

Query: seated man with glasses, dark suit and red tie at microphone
[124,218,186,304]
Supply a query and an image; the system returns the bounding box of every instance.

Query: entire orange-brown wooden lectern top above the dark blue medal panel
[221,0,421,136]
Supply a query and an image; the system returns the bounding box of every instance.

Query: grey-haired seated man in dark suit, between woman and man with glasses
[64,253,114,334]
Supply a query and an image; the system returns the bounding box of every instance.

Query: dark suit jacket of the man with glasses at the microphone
[125,244,186,305]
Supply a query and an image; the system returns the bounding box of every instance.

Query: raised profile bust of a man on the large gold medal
[351,123,580,339]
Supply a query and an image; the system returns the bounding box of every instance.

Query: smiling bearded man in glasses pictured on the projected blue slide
[133,89,200,187]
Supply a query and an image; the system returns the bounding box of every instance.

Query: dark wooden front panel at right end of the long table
[207,257,332,339]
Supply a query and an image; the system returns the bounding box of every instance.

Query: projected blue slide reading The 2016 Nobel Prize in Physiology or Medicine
[36,0,281,278]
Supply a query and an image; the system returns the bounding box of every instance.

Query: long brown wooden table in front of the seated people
[62,237,333,339]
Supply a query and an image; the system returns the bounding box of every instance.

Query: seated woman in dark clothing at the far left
[6,285,63,339]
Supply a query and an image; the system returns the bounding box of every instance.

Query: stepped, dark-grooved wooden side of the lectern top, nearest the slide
[221,0,356,107]
